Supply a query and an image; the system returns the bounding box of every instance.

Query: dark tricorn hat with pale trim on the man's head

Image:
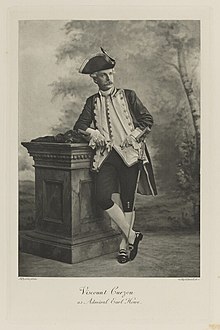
[79,48,115,74]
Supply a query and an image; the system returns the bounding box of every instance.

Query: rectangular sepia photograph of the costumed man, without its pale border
[18,19,201,278]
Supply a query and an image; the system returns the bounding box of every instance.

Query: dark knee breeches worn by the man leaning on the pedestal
[96,149,138,212]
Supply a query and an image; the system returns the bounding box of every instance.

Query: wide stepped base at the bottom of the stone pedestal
[19,230,121,264]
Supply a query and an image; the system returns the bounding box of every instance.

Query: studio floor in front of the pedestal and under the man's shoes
[19,231,200,278]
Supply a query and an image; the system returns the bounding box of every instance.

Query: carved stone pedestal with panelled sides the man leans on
[20,142,120,263]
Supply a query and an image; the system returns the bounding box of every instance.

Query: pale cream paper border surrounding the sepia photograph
[2,1,219,330]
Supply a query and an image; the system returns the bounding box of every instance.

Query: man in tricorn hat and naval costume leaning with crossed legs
[74,49,157,263]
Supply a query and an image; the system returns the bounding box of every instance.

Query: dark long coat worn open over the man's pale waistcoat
[74,89,157,195]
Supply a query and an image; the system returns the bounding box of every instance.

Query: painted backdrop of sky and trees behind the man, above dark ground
[19,20,200,228]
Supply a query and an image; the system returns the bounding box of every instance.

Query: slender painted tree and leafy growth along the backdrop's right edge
[149,21,200,225]
